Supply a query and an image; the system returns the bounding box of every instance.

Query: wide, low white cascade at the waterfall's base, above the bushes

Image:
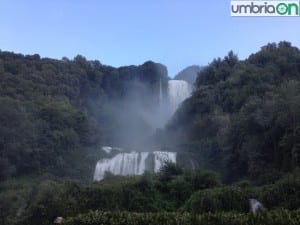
[94,151,176,181]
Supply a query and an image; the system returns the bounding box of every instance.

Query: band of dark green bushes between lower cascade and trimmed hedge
[0,170,300,225]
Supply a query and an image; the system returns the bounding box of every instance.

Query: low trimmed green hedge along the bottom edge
[64,210,300,225]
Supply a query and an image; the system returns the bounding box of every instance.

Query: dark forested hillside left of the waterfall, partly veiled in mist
[0,52,167,180]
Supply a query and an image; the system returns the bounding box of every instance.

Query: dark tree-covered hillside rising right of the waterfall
[164,42,300,181]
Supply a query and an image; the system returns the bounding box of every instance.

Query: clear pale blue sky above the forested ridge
[0,0,300,77]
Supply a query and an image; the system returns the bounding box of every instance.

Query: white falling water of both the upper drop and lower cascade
[94,80,192,181]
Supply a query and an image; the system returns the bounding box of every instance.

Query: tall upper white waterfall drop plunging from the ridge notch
[168,80,192,114]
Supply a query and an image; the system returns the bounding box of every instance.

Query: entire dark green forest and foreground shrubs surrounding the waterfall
[0,42,300,225]
